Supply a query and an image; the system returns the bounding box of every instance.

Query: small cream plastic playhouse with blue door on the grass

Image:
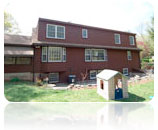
[97,69,128,100]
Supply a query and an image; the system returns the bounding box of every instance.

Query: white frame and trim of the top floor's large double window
[46,24,65,39]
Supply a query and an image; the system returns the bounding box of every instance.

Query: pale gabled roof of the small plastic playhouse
[97,69,125,80]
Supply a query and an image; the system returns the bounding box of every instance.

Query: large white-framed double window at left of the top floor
[46,24,65,39]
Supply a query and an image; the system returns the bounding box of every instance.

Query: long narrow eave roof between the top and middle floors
[33,41,141,51]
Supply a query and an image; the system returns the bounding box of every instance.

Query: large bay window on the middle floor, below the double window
[42,47,66,62]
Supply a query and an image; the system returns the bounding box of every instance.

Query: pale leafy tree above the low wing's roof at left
[4,12,20,34]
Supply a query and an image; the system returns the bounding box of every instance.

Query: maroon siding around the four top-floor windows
[38,20,136,47]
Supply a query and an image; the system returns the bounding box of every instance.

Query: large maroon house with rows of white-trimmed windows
[4,18,141,83]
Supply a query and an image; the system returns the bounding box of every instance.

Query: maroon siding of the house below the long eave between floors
[35,48,140,82]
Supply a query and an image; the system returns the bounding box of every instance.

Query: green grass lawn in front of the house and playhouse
[4,81,154,102]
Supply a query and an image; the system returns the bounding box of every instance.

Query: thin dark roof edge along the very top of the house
[39,18,136,35]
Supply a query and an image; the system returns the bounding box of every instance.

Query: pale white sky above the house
[4,0,154,35]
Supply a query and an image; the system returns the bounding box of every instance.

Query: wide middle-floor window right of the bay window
[85,49,107,62]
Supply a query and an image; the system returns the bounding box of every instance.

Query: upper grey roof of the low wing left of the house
[4,34,32,46]
